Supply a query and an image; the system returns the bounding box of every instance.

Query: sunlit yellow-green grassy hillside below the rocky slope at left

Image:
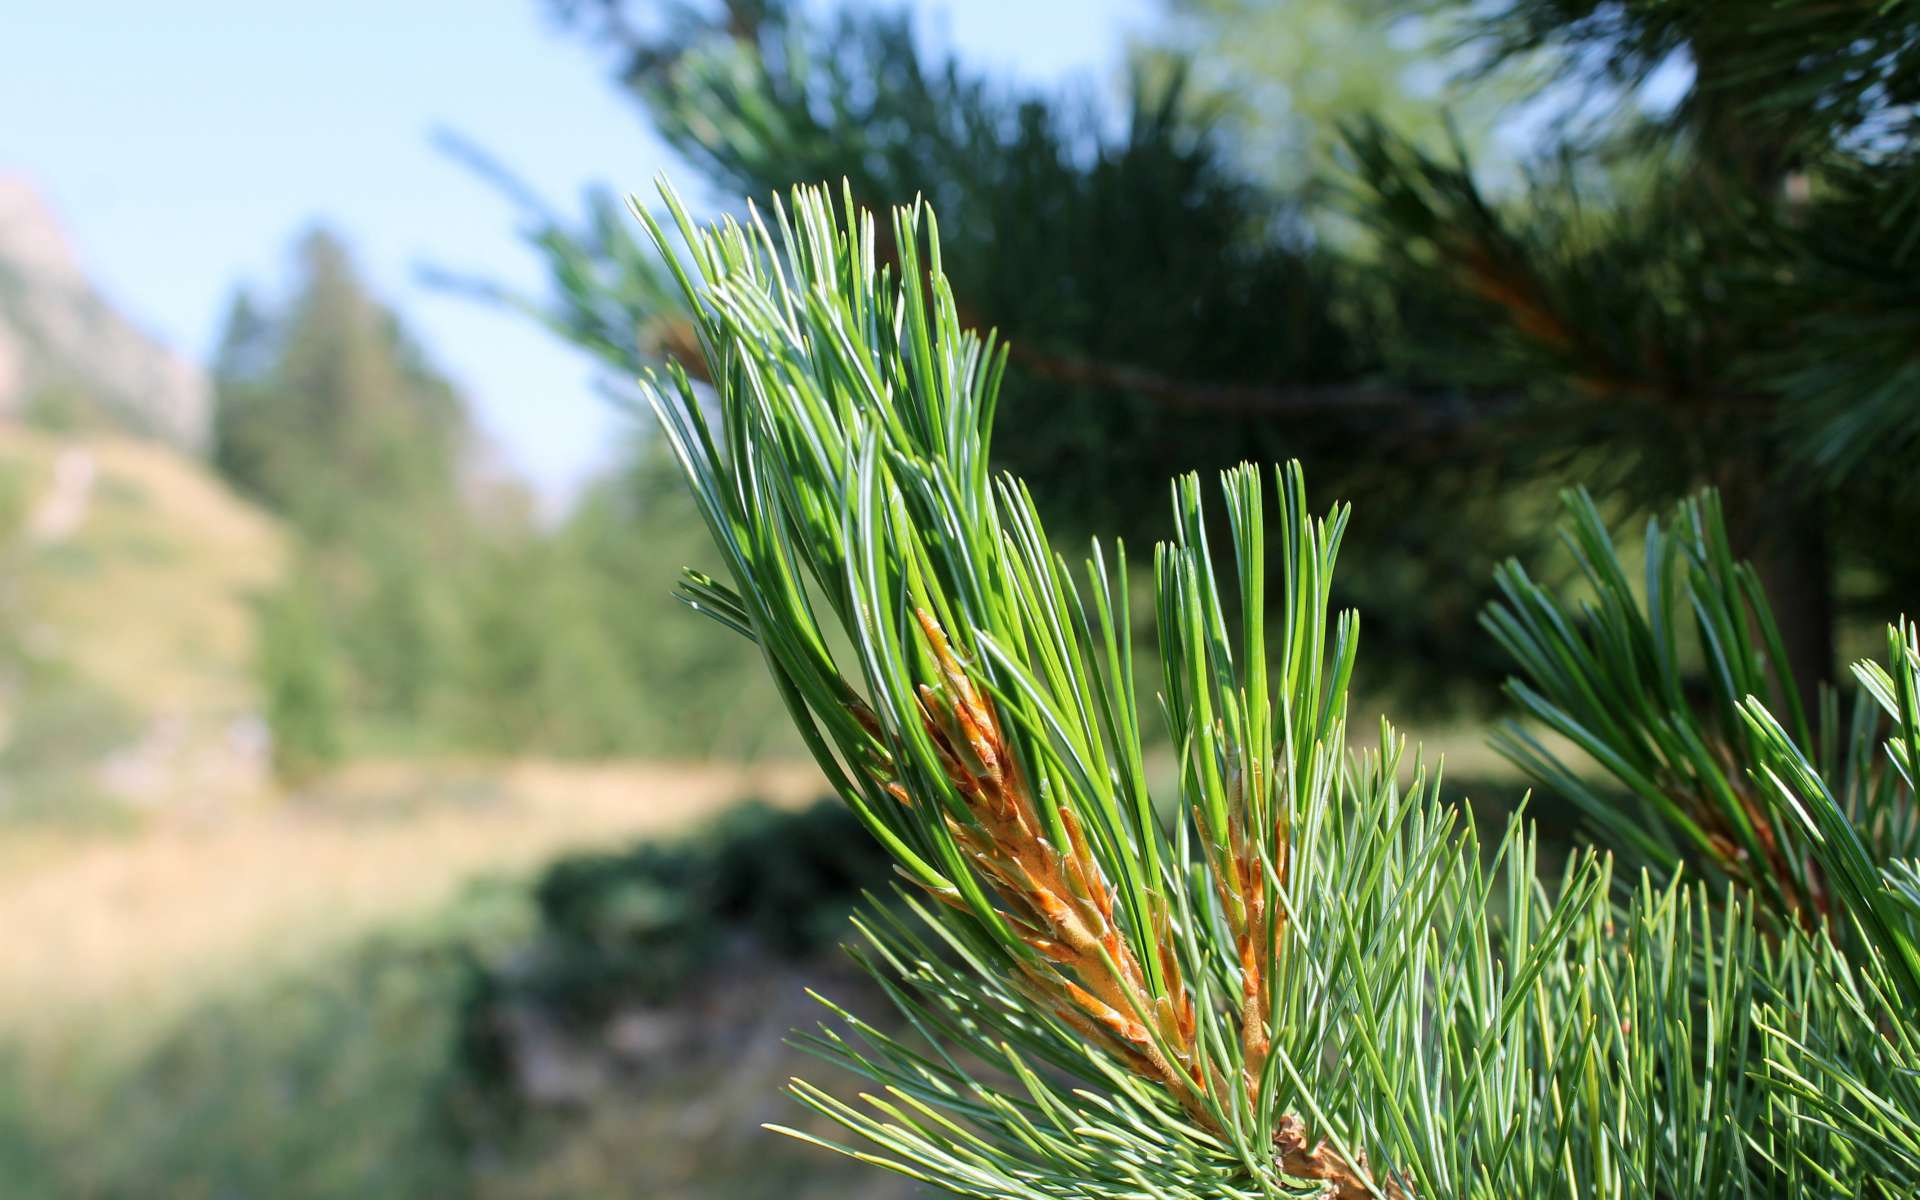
[0,426,286,816]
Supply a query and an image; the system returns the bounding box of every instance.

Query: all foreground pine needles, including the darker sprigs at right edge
[636,180,1920,1200]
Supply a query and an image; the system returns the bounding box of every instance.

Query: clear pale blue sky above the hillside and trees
[0,0,1152,497]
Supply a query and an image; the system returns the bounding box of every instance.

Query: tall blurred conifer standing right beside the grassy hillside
[213,230,470,758]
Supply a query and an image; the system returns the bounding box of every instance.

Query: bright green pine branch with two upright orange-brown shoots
[636,177,1824,1200]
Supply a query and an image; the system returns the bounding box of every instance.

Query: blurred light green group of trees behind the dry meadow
[213,225,810,778]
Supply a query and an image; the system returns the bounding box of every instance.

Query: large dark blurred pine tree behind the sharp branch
[499,0,1920,703]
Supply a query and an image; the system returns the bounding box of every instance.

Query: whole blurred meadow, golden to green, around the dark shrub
[0,762,845,1200]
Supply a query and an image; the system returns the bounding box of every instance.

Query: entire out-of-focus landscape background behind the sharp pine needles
[0,0,1920,1200]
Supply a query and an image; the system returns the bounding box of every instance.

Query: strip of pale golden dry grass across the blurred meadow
[0,762,818,1041]
